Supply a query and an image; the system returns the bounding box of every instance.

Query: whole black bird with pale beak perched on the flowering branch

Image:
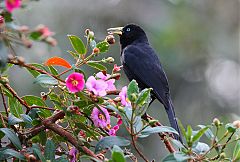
[108,24,182,141]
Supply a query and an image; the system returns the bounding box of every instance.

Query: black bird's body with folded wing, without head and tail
[122,45,169,105]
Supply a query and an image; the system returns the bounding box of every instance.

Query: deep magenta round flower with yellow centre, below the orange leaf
[66,72,85,93]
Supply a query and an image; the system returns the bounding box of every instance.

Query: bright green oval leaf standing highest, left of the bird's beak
[68,35,86,54]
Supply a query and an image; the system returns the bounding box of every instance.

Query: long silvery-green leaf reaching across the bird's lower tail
[141,126,178,137]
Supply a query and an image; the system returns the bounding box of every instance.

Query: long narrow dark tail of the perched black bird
[164,99,182,142]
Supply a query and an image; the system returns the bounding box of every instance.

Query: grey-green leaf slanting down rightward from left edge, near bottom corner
[0,128,22,150]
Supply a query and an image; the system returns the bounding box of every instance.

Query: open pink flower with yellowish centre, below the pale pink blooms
[91,107,110,128]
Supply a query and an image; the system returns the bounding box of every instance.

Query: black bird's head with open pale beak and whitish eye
[108,24,148,48]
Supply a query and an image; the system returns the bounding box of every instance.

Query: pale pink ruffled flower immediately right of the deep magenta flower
[86,76,108,97]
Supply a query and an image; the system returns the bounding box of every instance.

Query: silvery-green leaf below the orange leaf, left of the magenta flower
[33,74,58,87]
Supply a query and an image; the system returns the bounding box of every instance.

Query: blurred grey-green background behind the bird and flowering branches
[3,0,240,161]
